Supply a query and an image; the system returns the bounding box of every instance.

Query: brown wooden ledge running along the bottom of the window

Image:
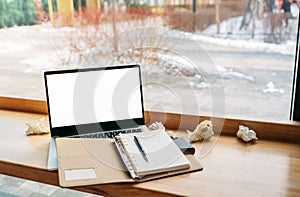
[0,97,300,143]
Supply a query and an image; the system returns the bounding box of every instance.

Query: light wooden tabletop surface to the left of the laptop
[0,110,50,169]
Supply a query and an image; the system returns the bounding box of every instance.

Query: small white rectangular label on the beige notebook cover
[65,168,97,181]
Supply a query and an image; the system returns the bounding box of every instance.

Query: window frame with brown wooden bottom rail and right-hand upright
[0,11,300,143]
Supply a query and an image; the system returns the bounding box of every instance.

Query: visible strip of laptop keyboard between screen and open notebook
[72,128,142,138]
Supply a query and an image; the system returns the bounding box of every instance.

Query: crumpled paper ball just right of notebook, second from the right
[187,120,214,142]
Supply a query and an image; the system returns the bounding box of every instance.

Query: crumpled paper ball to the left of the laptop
[25,118,49,135]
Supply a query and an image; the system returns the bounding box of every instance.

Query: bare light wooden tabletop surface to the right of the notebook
[138,133,300,197]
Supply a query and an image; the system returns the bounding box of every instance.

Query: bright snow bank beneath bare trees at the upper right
[191,13,298,55]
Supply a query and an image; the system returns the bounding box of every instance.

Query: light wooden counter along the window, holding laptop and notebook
[0,110,300,196]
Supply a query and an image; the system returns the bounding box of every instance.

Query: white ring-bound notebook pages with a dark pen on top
[115,130,190,178]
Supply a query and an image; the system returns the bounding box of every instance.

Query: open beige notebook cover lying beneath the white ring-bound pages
[56,132,203,187]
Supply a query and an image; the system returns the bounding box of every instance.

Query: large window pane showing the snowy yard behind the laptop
[0,0,299,121]
